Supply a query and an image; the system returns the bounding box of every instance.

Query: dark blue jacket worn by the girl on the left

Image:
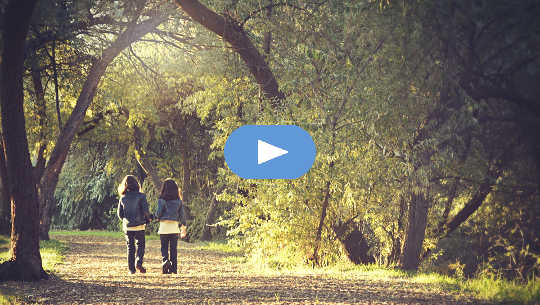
[117,190,151,227]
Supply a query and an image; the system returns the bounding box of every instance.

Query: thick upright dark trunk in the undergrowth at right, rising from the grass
[400,193,428,270]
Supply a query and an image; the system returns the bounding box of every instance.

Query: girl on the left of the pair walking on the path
[117,175,152,274]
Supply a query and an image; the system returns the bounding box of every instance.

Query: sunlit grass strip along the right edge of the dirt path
[189,241,540,305]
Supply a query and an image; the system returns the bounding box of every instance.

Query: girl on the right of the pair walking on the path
[156,179,186,274]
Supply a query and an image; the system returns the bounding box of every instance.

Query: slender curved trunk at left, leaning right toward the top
[39,15,167,238]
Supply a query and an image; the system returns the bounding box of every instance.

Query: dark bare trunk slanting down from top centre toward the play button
[176,0,285,105]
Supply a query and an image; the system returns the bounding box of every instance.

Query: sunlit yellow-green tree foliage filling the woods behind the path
[19,1,540,292]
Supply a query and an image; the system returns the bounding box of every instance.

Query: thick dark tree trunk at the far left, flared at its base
[0,0,47,281]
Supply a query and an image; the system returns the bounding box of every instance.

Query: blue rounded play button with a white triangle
[224,125,316,179]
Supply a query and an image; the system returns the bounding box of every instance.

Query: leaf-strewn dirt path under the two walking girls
[0,236,478,304]
